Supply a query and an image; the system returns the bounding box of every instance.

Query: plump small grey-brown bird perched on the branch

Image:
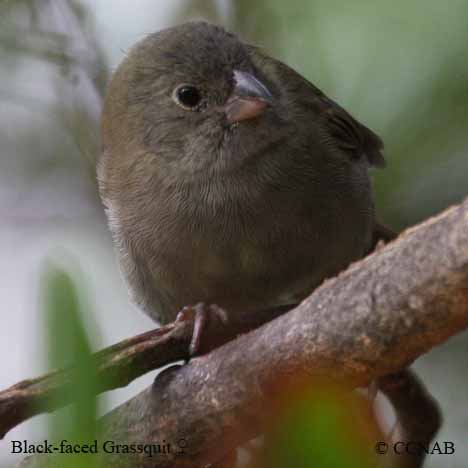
[98,22,384,352]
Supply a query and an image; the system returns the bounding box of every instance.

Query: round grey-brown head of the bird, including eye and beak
[103,22,285,183]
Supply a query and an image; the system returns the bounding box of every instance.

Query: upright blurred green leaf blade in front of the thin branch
[44,267,99,468]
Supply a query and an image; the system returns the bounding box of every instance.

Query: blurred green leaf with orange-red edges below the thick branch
[250,382,378,468]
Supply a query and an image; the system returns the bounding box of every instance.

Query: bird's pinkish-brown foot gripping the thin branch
[176,302,229,359]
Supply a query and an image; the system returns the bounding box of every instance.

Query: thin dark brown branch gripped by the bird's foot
[0,294,283,439]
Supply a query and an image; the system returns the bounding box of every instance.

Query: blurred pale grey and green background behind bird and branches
[0,0,468,468]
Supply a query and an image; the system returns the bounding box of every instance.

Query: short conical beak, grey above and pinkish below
[224,70,273,124]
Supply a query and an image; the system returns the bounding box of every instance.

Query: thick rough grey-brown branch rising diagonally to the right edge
[16,196,468,467]
